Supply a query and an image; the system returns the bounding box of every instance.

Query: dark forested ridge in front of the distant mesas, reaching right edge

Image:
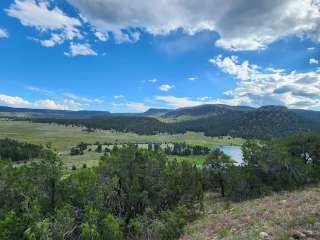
[23,106,320,139]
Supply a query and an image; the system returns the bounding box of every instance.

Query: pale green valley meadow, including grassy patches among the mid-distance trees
[0,119,244,170]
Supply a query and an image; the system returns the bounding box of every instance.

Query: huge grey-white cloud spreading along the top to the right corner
[68,0,320,51]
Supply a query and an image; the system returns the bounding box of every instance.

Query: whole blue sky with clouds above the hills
[0,0,320,112]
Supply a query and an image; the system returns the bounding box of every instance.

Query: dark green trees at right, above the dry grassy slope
[203,134,320,201]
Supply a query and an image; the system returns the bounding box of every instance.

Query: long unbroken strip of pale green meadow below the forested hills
[0,120,244,152]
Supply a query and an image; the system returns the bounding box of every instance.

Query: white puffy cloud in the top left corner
[5,0,83,47]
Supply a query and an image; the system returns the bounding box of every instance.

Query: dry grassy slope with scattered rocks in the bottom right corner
[181,186,320,240]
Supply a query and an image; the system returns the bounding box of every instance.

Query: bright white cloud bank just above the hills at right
[210,55,320,108]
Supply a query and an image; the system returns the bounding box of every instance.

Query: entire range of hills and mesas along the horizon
[0,104,320,139]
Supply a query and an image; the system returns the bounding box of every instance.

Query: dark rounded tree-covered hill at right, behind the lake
[176,106,320,139]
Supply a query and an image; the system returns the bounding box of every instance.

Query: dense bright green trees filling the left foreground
[0,146,203,240]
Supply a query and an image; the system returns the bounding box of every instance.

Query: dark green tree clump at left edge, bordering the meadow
[0,138,43,162]
